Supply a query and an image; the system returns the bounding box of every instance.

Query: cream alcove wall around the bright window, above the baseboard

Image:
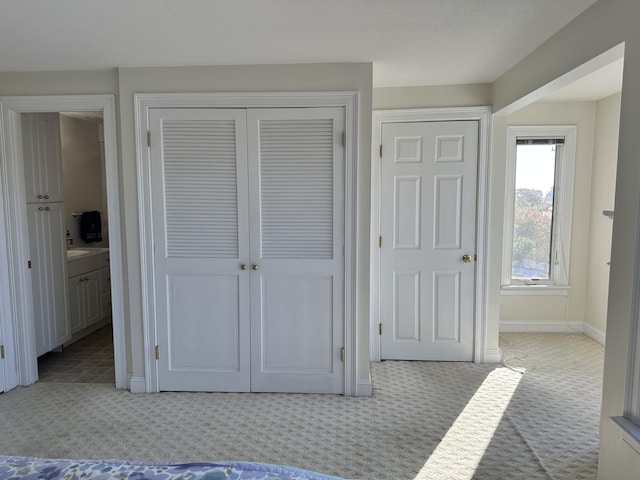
[493,102,606,331]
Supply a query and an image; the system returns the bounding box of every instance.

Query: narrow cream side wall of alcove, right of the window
[584,94,620,343]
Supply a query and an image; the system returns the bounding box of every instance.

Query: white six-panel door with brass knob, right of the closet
[380,121,478,361]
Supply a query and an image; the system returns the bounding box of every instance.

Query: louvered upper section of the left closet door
[162,120,238,258]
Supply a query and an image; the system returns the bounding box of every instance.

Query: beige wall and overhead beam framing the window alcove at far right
[490,0,640,480]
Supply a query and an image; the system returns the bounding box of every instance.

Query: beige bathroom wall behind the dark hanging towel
[60,115,109,247]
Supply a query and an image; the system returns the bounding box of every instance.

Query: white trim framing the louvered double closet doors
[134,92,359,396]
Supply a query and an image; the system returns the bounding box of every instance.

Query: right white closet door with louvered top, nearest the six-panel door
[247,108,344,393]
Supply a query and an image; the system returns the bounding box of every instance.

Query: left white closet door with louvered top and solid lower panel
[149,109,250,391]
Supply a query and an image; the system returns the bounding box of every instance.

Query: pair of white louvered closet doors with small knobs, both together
[149,107,344,393]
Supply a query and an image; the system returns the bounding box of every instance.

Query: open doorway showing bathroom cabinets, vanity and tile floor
[21,112,115,384]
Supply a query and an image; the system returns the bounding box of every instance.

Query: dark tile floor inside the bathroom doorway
[38,324,115,384]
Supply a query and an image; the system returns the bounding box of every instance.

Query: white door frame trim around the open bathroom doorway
[0,95,128,389]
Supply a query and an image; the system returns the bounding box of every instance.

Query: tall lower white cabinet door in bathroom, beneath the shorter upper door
[27,203,71,356]
